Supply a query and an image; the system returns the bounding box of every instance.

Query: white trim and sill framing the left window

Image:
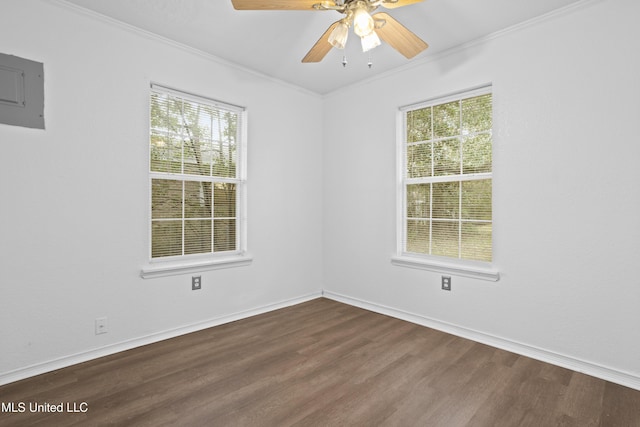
[140,83,253,279]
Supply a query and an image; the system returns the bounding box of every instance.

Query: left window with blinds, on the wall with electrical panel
[149,85,245,260]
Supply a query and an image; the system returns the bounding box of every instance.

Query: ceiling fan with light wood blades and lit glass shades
[231,0,429,62]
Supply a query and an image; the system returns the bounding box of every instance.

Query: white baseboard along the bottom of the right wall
[322,290,640,390]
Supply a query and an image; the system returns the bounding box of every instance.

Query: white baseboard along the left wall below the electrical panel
[0,291,322,385]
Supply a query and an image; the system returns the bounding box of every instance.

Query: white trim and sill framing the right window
[391,85,500,282]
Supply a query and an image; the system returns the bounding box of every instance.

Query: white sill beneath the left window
[140,254,253,279]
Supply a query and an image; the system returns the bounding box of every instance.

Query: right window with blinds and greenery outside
[399,87,492,268]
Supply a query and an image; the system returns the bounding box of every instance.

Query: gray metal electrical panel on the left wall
[0,53,44,129]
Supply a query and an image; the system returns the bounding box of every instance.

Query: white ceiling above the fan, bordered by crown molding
[66,0,580,94]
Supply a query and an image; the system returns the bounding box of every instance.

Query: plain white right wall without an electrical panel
[324,0,640,386]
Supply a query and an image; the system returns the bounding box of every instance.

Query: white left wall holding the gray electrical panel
[0,0,323,382]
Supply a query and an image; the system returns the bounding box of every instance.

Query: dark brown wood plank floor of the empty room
[0,299,640,427]
